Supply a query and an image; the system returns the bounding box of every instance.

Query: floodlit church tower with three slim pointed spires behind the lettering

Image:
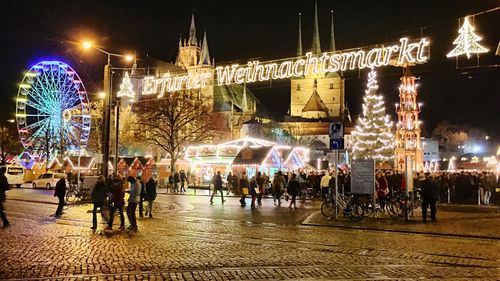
[289,3,345,119]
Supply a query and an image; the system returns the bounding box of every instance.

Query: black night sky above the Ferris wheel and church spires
[0,0,500,137]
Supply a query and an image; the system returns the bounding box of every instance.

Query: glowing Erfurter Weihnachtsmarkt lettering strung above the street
[142,37,430,97]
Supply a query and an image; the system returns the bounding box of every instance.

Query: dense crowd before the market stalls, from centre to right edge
[210,167,499,223]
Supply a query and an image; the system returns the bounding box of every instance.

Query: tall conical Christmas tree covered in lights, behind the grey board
[352,69,394,160]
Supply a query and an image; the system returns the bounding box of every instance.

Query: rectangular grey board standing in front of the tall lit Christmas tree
[351,159,375,194]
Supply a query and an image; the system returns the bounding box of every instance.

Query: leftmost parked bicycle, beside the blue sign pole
[321,192,365,221]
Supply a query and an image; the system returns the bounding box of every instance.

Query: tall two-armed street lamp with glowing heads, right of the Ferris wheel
[82,41,134,179]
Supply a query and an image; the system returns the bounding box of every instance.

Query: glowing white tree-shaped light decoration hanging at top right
[446,17,489,58]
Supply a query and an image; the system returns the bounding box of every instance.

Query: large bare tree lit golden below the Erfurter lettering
[136,92,218,172]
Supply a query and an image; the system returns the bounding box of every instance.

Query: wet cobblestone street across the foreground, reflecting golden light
[0,196,500,280]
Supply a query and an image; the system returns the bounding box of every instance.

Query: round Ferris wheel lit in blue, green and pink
[16,61,91,158]
